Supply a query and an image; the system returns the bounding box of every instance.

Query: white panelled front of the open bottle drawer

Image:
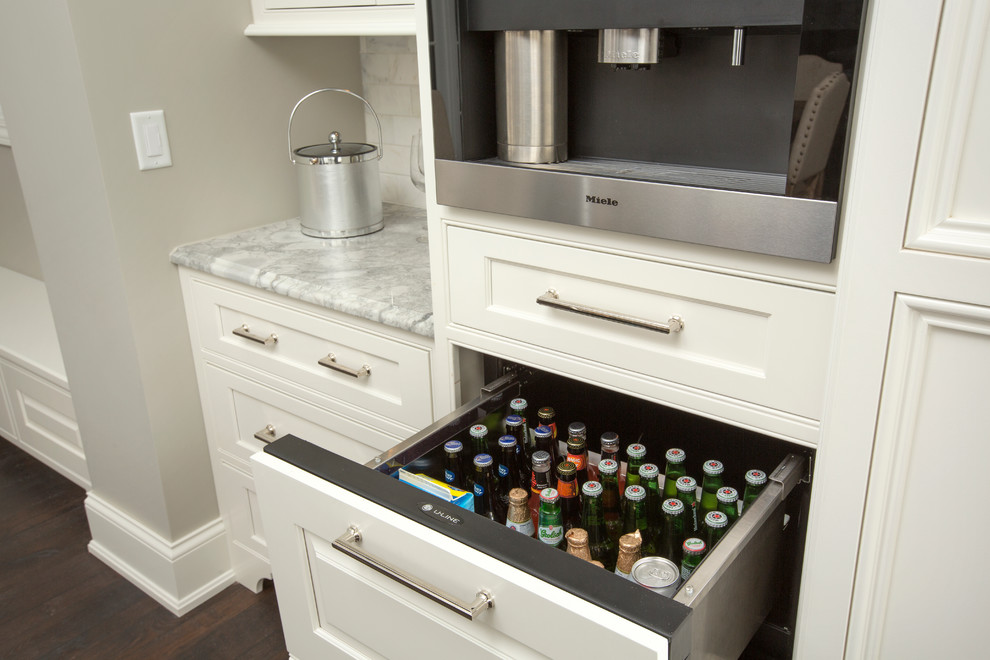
[254,454,668,660]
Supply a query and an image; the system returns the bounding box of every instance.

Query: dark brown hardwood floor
[0,438,288,660]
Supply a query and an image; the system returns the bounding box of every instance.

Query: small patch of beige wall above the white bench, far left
[0,146,42,280]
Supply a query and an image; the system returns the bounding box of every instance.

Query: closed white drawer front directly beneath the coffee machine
[446,226,834,419]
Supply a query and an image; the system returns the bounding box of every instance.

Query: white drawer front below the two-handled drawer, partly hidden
[204,364,403,470]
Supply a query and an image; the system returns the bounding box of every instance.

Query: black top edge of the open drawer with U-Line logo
[265,435,691,646]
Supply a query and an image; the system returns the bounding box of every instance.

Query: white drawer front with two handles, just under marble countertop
[192,279,432,429]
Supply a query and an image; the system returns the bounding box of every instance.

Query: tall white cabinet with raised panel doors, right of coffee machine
[795,0,990,659]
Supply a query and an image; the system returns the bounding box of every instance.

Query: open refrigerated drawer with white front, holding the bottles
[252,366,806,660]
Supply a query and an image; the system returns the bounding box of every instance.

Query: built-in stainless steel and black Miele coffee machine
[430,0,863,262]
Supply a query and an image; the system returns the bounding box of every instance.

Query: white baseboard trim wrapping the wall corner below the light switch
[85,493,234,616]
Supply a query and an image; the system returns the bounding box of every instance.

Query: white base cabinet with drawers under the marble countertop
[179,268,433,589]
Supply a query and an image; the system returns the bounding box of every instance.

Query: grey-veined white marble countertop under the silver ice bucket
[170,204,433,337]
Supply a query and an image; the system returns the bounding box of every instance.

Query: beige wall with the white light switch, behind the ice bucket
[0,0,363,540]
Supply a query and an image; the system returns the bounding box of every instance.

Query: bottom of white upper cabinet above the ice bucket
[244,0,416,36]
